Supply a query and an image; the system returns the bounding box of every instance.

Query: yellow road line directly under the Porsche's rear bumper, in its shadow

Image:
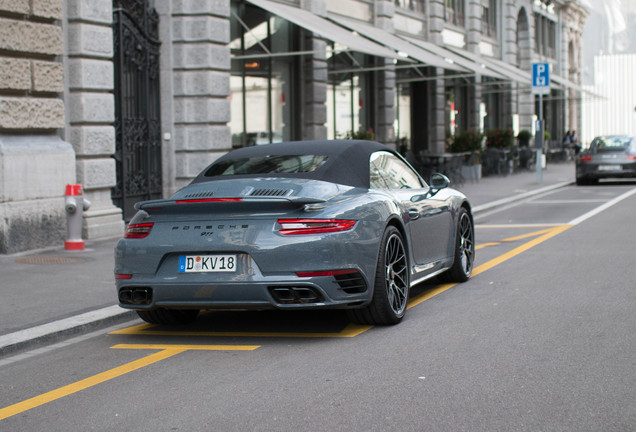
[109,323,373,338]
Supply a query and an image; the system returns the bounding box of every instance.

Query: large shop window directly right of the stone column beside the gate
[230,4,295,147]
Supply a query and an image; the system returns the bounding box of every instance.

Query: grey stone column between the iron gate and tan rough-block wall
[65,0,124,239]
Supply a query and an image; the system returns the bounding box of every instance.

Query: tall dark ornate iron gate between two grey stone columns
[111,0,162,221]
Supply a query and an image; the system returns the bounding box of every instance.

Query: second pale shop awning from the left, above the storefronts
[329,15,467,72]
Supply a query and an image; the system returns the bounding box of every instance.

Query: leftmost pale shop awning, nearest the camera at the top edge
[247,0,399,59]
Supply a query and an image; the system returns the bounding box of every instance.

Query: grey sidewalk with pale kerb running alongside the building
[0,162,574,357]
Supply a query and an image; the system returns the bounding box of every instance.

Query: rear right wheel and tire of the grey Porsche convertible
[348,226,409,325]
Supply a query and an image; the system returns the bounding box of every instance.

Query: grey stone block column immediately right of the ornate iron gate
[171,0,232,188]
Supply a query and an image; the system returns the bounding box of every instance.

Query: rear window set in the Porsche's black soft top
[205,155,327,177]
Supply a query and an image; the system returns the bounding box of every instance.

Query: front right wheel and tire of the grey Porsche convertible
[441,207,475,282]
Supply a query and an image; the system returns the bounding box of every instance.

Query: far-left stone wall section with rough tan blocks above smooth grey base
[0,0,75,254]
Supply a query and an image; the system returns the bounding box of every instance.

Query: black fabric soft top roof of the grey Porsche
[192,140,397,189]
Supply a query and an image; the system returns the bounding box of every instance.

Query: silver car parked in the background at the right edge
[576,135,636,185]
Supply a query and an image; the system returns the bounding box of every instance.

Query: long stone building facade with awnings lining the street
[0,0,586,254]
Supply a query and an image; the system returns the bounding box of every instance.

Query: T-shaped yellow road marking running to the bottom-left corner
[0,344,259,420]
